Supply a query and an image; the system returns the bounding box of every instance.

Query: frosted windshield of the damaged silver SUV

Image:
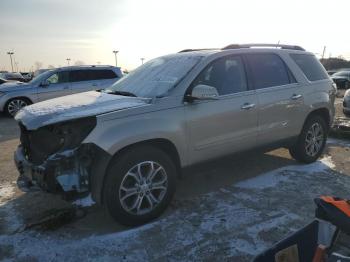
[105,53,202,97]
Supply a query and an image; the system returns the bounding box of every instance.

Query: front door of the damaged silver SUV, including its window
[185,55,257,163]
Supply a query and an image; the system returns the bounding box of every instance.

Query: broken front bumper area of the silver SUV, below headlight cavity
[14,144,94,193]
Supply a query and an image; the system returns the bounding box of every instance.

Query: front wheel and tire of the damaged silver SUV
[103,146,176,226]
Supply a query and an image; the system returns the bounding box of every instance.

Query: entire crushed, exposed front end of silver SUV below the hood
[14,117,98,198]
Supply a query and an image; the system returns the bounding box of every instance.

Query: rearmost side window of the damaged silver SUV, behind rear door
[290,54,328,81]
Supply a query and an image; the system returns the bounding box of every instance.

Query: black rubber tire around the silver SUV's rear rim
[290,115,328,163]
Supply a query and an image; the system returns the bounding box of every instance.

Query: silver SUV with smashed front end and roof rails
[15,44,336,225]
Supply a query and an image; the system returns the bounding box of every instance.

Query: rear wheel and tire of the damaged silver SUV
[289,115,328,164]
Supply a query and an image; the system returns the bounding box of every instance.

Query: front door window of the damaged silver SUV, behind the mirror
[191,56,248,95]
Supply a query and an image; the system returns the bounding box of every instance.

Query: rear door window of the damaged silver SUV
[247,54,295,89]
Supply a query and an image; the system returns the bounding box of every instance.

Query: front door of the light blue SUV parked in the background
[37,71,71,101]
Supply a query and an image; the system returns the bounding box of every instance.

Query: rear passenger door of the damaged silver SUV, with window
[245,53,305,145]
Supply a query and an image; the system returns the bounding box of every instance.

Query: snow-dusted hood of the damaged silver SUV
[15,91,150,130]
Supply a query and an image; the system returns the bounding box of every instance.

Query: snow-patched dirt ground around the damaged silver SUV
[0,95,350,261]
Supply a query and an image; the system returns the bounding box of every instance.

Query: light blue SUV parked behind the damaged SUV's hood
[0,66,122,116]
